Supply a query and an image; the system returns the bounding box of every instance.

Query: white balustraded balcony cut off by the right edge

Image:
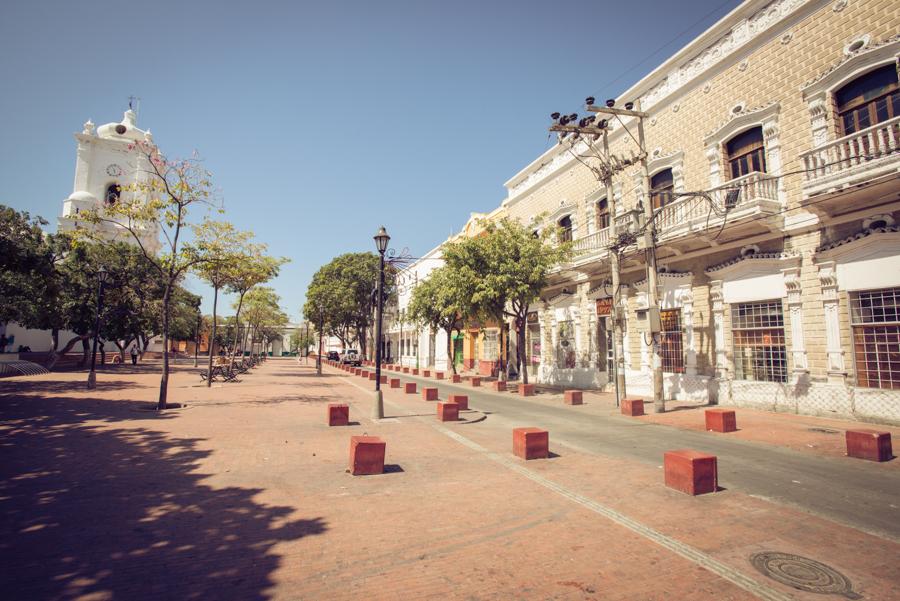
[800,117,900,216]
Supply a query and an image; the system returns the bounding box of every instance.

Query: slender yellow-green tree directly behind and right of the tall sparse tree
[194,219,253,387]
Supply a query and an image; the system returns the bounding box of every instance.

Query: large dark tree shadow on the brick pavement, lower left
[0,386,327,601]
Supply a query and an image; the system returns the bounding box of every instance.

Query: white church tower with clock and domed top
[58,108,160,254]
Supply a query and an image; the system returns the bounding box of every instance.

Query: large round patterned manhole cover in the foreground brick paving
[750,551,862,599]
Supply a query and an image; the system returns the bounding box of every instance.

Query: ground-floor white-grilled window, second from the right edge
[731,300,787,382]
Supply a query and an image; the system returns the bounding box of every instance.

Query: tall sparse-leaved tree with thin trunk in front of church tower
[82,140,211,411]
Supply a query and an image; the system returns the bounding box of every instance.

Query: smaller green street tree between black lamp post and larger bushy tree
[407,266,471,373]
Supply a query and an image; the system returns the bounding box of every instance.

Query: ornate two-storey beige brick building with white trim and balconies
[502,0,900,422]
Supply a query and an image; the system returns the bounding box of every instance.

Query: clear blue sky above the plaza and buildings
[0,0,738,319]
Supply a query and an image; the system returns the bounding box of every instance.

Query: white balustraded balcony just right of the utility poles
[655,172,782,254]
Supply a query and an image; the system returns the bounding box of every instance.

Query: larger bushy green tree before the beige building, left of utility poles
[444,218,572,384]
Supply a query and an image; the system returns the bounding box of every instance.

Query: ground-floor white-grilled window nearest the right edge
[850,288,900,390]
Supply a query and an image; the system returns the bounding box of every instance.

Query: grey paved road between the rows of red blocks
[403,374,900,541]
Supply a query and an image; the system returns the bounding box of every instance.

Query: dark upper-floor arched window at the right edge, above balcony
[834,63,900,136]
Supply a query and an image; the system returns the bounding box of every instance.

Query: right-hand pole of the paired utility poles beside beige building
[637,99,666,413]
